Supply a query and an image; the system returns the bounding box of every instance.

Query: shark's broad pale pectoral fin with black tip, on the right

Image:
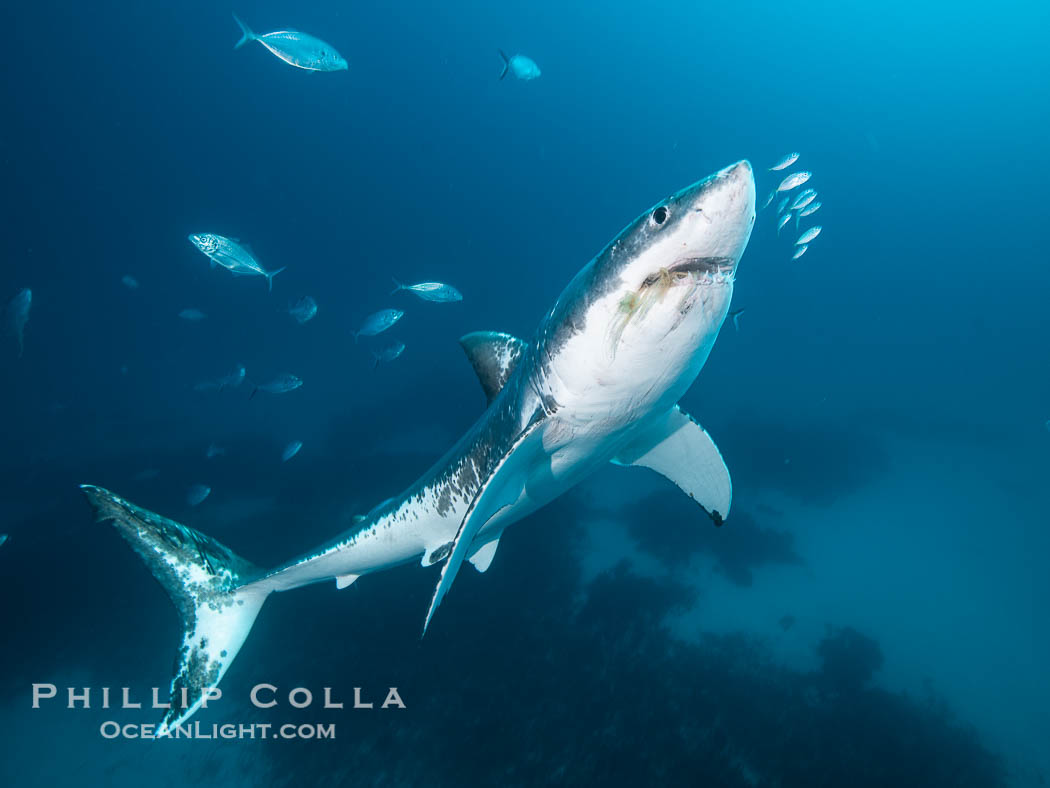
[613,406,733,525]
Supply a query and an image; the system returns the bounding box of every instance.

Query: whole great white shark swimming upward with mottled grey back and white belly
[82,161,755,734]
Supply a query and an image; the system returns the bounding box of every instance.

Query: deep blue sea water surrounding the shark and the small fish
[0,0,1050,786]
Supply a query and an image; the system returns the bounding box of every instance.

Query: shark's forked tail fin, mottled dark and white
[81,484,270,735]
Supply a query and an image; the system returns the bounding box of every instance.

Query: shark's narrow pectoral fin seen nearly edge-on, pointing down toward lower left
[423,418,544,635]
